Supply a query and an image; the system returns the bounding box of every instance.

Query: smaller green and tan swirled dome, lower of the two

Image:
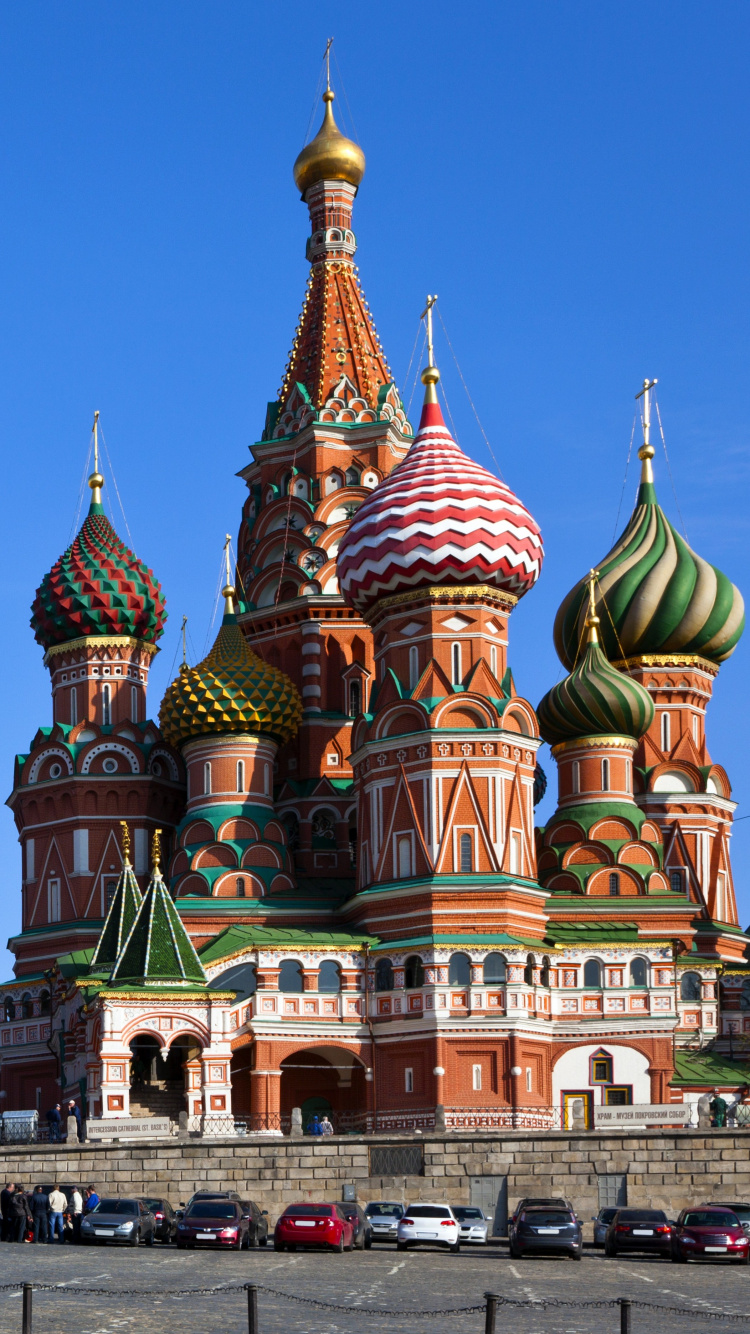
[536,576,654,746]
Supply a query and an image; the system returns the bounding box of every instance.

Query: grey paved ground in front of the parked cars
[0,1245,750,1334]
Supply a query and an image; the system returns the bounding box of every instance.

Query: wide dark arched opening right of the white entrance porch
[280,1046,367,1130]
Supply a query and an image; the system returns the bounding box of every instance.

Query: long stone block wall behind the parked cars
[0,1130,750,1219]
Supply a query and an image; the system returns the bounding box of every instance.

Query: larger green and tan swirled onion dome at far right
[554,397,745,667]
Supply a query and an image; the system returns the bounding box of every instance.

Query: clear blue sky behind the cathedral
[0,0,750,971]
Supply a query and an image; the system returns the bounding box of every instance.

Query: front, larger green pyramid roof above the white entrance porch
[109,870,207,986]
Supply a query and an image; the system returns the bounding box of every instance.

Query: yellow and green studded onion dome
[159,608,302,746]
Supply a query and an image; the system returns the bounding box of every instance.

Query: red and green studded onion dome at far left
[31,471,167,648]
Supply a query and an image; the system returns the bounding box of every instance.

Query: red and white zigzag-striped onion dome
[336,402,544,614]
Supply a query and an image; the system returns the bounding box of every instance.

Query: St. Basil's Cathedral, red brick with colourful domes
[0,78,750,1133]
